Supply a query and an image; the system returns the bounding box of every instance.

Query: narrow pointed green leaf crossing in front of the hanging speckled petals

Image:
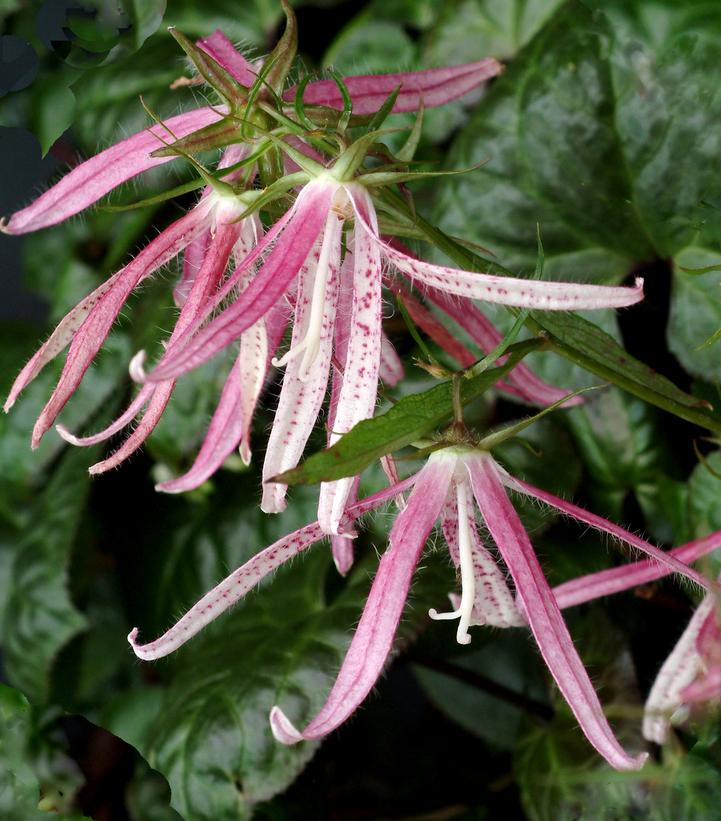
[277,340,538,484]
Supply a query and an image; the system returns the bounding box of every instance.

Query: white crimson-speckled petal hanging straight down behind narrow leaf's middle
[318,186,382,534]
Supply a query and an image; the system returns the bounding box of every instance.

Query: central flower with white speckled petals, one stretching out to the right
[141,169,642,534]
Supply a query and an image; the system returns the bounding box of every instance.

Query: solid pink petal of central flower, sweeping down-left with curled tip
[149,183,334,381]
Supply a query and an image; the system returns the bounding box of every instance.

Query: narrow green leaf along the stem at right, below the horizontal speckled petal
[531,311,721,431]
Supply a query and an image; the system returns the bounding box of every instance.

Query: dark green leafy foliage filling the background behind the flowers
[0,0,721,821]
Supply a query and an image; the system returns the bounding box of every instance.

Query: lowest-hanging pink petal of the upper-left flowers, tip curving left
[155,354,243,493]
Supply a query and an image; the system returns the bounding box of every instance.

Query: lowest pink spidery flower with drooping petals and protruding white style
[129,447,708,769]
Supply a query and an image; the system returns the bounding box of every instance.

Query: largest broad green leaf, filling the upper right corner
[436,0,721,262]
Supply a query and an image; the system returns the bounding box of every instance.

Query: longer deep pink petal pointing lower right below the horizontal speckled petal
[420,282,583,407]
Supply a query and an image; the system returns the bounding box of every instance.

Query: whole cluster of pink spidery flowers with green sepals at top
[7,6,696,769]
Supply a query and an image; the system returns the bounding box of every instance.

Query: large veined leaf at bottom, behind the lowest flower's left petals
[141,547,365,821]
